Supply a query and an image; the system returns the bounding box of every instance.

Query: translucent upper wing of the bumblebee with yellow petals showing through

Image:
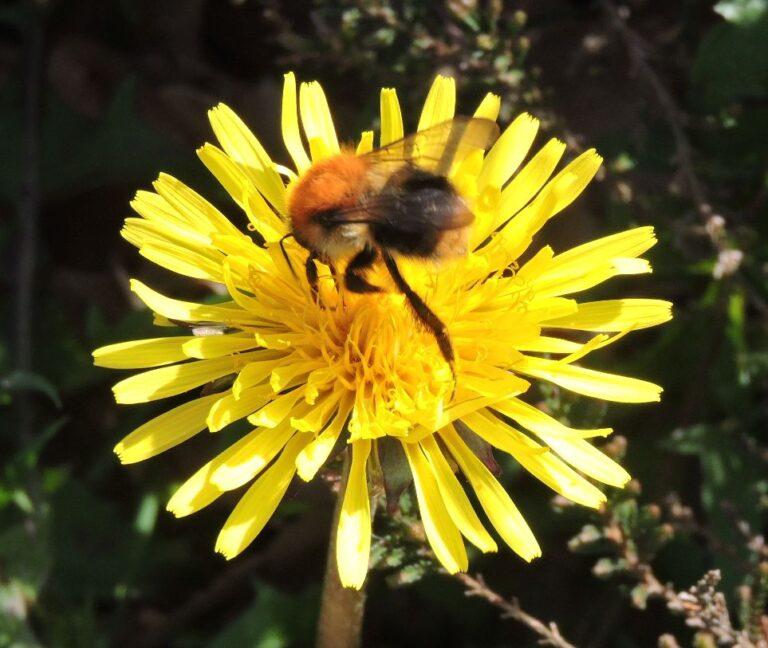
[365,116,499,176]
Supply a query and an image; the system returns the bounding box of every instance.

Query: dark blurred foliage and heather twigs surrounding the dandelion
[0,0,768,648]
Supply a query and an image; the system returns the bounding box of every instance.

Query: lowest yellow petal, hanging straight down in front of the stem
[336,439,371,589]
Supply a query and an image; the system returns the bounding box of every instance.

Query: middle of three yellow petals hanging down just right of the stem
[421,436,498,552]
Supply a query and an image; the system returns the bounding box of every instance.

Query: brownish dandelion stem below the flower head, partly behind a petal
[317,448,365,648]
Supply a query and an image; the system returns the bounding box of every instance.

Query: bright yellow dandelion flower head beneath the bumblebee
[94,74,671,588]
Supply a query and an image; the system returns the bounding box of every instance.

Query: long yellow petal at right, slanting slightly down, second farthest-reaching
[515,357,662,403]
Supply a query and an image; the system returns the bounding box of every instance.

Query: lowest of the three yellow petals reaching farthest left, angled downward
[115,394,221,464]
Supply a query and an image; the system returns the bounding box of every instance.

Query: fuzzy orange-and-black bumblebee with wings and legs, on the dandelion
[281,117,499,371]
